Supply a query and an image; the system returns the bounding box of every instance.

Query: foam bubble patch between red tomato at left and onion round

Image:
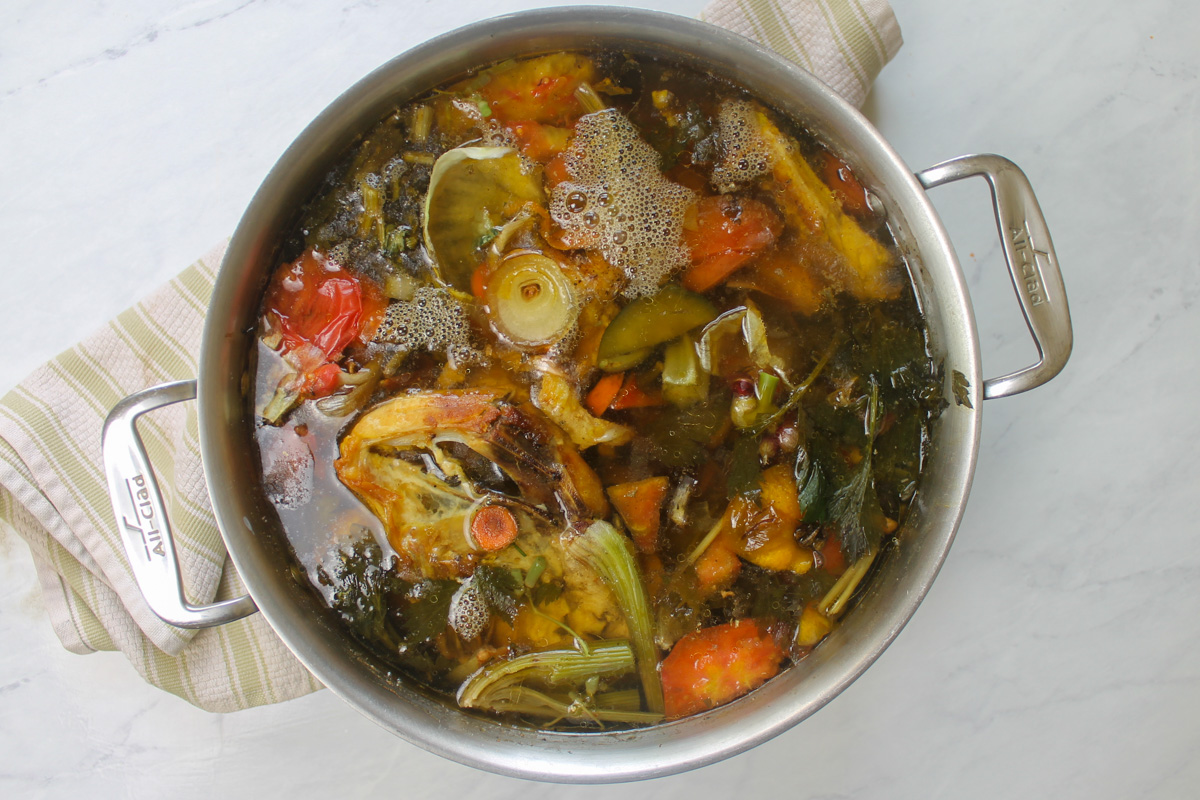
[374,287,479,361]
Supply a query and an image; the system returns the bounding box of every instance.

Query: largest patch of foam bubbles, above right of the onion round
[550,109,695,297]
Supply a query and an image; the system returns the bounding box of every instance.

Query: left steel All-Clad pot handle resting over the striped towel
[103,380,258,628]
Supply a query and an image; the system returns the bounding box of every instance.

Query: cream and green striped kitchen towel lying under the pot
[0,0,900,711]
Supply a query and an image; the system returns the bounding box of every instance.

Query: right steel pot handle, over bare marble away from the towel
[917,155,1072,399]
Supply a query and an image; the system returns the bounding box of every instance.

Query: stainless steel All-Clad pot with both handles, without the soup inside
[104,7,1072,783]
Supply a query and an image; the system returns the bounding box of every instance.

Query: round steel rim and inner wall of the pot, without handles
[198,6,982,783]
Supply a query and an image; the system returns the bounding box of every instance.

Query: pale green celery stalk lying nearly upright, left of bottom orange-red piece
[570,519,662,712]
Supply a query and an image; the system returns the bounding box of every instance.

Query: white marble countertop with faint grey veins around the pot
[0,0,1200,800]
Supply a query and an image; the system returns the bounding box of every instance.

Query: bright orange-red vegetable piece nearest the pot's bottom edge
[661,619,786,720]
